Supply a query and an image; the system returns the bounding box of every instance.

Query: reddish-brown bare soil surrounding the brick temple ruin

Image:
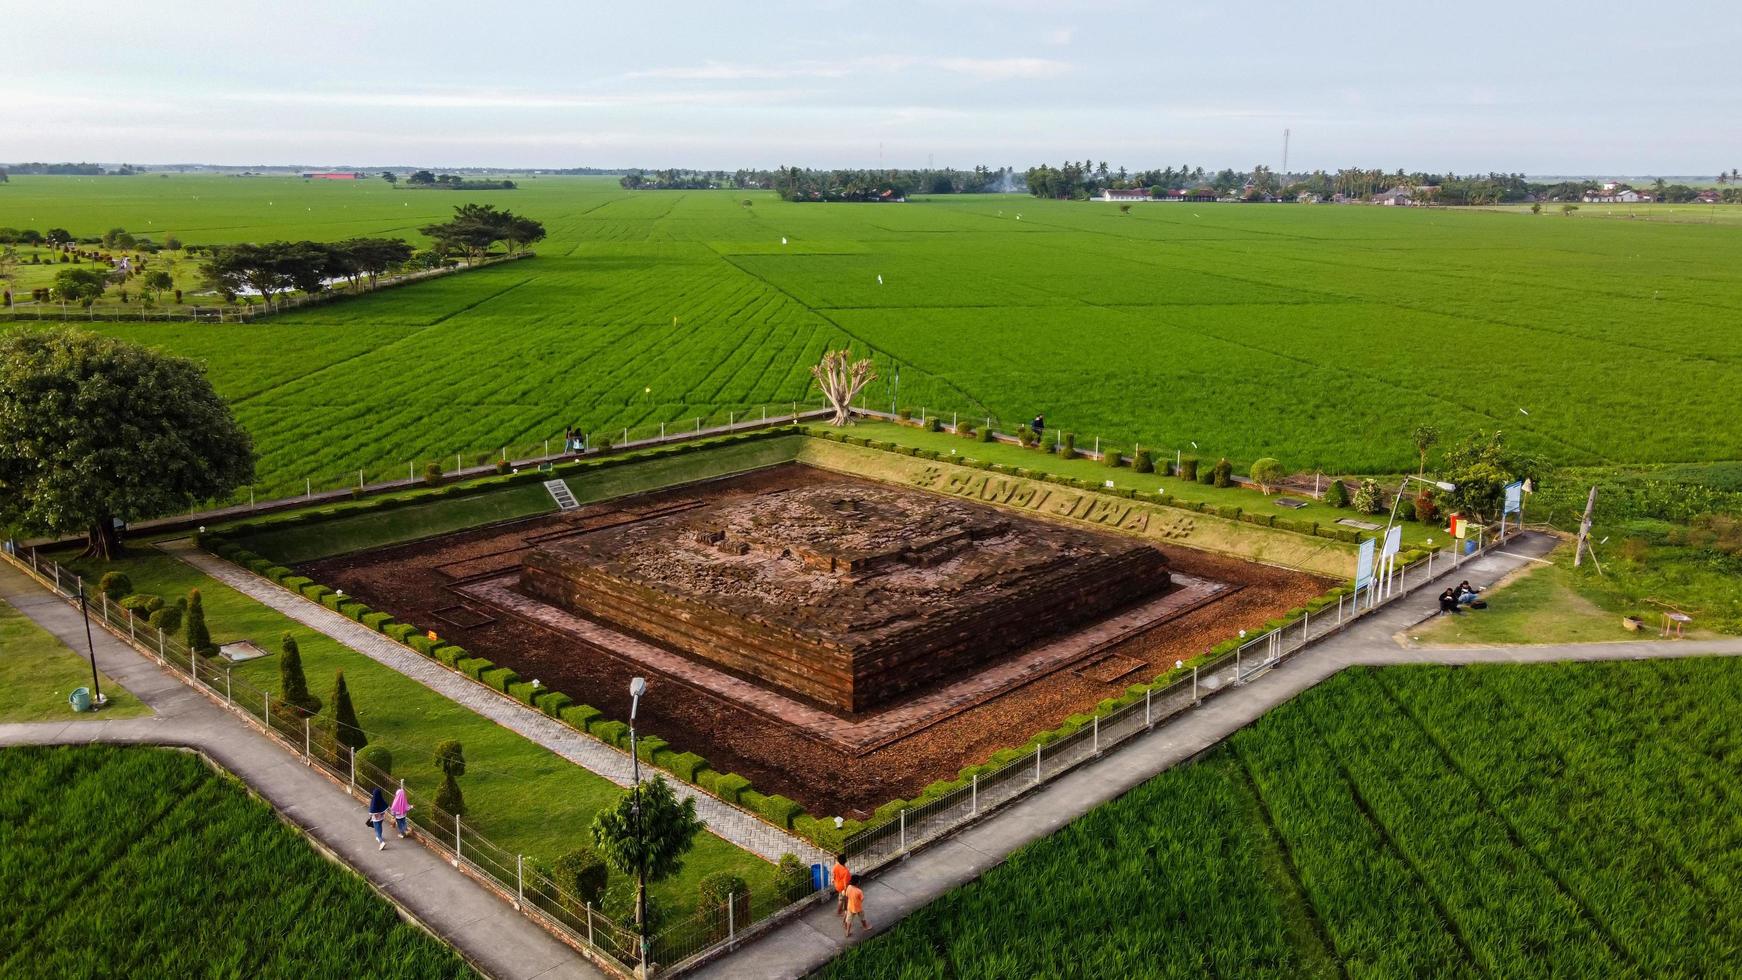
[305,468,1329,816]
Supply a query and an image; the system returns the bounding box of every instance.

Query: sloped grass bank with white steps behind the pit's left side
[242,435,803,564]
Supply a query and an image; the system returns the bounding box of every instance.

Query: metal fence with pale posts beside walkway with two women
[3,541,639,975]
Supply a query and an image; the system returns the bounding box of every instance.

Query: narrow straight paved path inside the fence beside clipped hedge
[159,540,824,863]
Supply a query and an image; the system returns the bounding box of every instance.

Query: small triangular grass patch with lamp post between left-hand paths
[0,599,152,722]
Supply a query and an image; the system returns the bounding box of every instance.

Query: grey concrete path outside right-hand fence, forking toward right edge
[697,534,1742,978]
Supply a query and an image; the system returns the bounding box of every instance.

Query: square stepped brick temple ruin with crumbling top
[519,480,1171,712]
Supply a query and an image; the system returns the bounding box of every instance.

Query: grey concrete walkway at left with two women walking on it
[0,562,606,980]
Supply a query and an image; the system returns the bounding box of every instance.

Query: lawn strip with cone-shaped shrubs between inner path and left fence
[61,553,773,910]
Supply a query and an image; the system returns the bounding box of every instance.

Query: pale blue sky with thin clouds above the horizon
[0,0,1742,176]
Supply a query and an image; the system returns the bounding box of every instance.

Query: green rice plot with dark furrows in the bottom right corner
[822,658,1742,978]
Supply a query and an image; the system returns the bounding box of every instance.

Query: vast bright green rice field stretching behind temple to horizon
[0,176,1742,493]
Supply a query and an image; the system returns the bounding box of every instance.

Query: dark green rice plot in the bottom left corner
[0,745,474,977]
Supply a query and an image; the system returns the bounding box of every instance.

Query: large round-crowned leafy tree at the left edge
[0,331,254,559]
